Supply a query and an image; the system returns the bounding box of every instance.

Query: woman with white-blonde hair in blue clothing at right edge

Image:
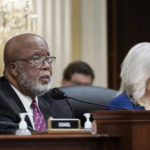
[108,42,150,110]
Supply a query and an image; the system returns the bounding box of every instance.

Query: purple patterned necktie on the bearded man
[31,100,47,131]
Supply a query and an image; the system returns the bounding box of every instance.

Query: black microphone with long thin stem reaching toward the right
[51,88,128,110]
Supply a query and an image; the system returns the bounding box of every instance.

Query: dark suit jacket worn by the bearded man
[0,77,73,134]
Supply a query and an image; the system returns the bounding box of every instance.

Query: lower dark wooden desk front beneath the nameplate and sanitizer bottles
[0,134,119,150]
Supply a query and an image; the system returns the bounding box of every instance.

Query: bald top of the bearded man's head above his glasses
[4,33,48,65]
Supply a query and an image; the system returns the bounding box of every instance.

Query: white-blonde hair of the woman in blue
[119,42,150,106]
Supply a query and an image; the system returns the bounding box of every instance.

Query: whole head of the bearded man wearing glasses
[3,33,52,98]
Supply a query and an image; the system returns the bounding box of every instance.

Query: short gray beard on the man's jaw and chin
[19,71,51,96]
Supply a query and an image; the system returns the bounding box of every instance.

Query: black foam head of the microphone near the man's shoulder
[50,88,67,99]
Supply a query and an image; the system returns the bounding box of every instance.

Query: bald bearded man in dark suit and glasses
[0,33,73,134]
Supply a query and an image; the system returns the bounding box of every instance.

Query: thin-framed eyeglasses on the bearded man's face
[11,56,56,68]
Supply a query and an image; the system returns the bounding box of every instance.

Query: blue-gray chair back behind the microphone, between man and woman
[59,85,117,124]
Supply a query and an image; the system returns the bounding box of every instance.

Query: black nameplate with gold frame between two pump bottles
[48,119,81,130]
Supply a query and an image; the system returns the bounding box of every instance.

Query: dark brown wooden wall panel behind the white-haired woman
[107,0,150,89]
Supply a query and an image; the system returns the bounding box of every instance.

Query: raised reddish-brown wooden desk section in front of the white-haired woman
[92,110,150,150]
